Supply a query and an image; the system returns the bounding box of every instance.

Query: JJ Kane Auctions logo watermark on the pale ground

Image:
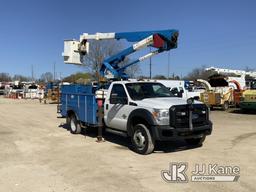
[161,162,240,183]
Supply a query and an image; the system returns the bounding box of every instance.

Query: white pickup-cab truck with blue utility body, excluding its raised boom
[60,81,212,154]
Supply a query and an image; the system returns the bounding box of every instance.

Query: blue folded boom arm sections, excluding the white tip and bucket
[100,30,178,79]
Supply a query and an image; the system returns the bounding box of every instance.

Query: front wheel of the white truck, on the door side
[131,124,155,155]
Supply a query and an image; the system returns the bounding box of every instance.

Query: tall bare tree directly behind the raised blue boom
[84,40,140,77]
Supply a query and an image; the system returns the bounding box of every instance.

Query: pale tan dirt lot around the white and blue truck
[0,98,256,192]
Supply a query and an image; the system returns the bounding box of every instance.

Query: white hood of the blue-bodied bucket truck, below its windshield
[136,97,201,109]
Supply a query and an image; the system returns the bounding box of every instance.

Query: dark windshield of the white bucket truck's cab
[126,83,174,100]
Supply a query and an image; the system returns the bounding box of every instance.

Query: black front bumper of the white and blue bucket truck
[152,121,212,141]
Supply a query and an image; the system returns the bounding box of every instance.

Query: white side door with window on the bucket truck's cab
[104,84,131,131]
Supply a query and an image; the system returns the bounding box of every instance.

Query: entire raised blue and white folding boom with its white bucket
[62,30,178,79]
